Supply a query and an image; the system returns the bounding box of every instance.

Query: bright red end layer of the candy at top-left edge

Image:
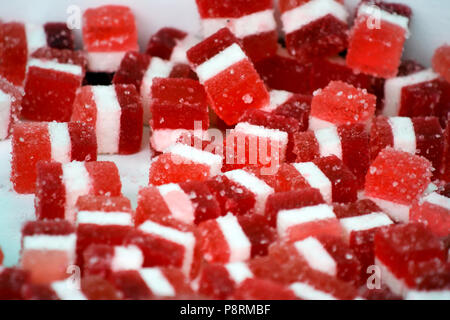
[0,22,28,86]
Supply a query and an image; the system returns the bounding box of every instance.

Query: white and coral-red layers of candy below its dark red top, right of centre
[277,204,342,242]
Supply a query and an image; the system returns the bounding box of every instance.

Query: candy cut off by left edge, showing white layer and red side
[0,76,23,140]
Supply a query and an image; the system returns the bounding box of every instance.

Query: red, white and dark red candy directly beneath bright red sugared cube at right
[294,123,370,186]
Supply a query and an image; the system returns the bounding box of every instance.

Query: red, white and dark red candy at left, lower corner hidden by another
[11,122,97,193]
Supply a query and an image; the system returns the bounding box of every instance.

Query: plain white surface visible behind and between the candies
[0,0,450,266]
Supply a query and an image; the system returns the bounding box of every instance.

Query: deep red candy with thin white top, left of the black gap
[21,53,84,122]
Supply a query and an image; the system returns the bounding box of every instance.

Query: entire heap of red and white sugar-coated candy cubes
[0,0,450,299]
